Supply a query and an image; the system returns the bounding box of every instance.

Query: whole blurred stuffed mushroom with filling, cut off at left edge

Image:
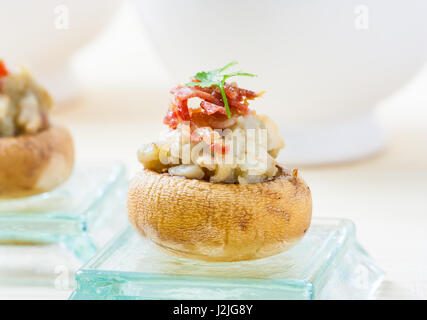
[0,60,74,199]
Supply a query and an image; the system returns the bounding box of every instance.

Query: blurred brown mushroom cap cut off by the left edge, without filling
[0,126,74,199]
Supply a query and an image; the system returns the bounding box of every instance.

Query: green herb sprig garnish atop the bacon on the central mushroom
[185,61,256,118]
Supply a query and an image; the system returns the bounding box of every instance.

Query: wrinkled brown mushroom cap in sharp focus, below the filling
[127,169,312,261]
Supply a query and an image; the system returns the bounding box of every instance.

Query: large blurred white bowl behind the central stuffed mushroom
[136,0,427,164]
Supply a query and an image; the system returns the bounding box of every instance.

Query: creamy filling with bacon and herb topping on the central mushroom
[138,63,284,184]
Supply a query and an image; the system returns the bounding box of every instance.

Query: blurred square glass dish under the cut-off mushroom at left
[0,164,127,285]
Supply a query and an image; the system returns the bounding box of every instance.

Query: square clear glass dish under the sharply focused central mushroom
[70,219,384,299]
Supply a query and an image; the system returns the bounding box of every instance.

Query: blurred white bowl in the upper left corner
[0,0,121,99]
